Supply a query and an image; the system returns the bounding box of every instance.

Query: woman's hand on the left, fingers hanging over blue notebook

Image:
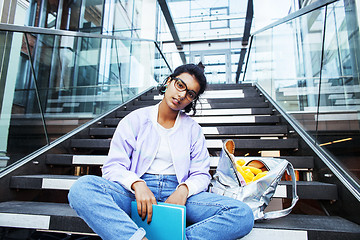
[131,181,157,223]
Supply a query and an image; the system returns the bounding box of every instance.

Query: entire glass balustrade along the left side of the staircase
[0,24,171,169]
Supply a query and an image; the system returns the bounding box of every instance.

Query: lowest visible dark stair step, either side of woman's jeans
[0,201,360,237]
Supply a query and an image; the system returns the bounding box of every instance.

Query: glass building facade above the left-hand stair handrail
[24,0,157,40]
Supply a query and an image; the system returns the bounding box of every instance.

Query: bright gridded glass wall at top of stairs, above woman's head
[158,0,248,83]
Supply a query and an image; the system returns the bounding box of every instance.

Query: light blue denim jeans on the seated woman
[68,174,254,240]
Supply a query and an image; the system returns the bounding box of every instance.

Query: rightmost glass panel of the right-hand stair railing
[317,1,360,179]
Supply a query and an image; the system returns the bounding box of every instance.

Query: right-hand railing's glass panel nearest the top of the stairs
[245,8,325,135]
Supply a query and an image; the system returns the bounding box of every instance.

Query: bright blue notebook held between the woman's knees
[131,201,186,240]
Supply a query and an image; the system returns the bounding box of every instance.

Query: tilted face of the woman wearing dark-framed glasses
[164,73,200,111]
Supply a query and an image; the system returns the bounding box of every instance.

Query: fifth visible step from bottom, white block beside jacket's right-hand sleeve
[89,125,287,138]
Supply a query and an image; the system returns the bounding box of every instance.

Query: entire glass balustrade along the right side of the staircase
[245,1,360,182]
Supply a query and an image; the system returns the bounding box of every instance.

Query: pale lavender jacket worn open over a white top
[102,104,210,196]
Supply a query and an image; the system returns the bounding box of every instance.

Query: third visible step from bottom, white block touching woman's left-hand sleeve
[46,154,314,169]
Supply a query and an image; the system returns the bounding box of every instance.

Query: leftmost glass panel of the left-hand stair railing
[0,31,48,167]
